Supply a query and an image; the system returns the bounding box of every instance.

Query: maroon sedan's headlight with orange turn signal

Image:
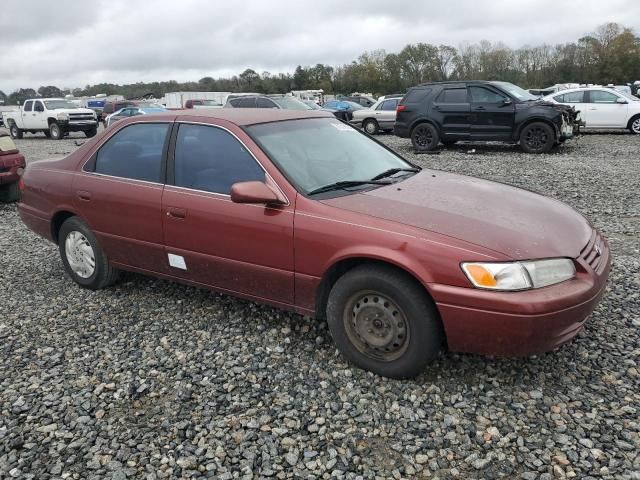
[462,258,576,290]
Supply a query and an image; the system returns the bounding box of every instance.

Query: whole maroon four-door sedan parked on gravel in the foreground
[19,109,610,377]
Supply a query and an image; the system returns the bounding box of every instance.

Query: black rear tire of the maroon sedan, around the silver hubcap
[58,217,120,290]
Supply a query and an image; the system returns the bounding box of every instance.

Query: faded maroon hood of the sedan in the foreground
[322,169,592,260]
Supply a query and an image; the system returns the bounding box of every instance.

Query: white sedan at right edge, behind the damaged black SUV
[544,87,640,135]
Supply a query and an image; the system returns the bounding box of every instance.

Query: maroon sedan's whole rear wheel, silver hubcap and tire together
[58,217,120,290]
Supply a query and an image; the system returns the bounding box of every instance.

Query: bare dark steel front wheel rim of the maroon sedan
[343,290,410,362]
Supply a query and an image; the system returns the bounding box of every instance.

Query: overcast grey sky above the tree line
[0,0,640,94]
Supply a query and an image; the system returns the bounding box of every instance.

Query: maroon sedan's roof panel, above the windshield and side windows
[141,108,335,126]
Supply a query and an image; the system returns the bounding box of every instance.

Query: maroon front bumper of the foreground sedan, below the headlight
[428,236,611,356]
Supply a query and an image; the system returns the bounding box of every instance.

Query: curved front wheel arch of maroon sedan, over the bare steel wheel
[315,255,441,321]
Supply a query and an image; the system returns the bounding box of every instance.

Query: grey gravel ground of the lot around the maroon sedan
[0,129,640,480]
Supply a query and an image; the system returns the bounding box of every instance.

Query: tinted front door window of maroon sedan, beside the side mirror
[175,125,265,194]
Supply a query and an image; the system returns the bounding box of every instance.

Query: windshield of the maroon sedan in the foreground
[247,118,412,194]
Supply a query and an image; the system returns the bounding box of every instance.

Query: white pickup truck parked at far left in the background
[2,98,98,140]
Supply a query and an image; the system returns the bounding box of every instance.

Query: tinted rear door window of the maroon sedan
[95,123,169,182]
